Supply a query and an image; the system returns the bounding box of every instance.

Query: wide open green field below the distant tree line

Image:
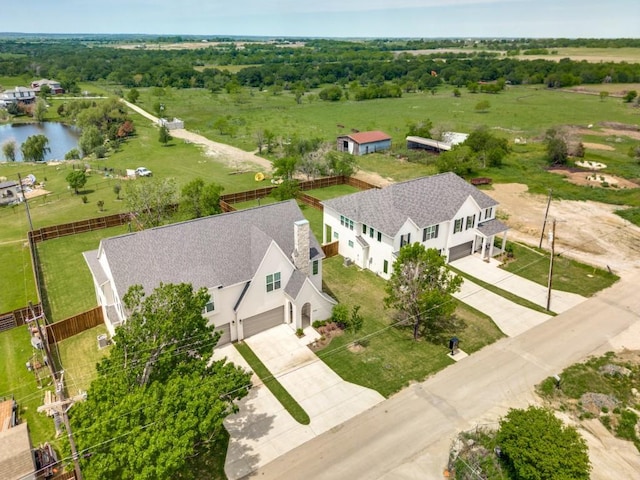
[132,86,640,150]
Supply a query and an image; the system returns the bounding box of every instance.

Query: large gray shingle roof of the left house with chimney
[101,200,324,295]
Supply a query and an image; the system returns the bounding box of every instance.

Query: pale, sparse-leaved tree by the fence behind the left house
[125,178,177,228]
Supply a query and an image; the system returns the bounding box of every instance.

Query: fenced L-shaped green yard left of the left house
[37,225,128,322]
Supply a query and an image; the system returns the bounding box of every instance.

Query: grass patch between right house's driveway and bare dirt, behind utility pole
[502,242,619,297]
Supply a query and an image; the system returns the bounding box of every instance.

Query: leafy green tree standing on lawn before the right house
[384,242,462,340]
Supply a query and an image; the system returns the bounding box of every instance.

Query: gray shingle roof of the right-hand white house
[322,172,498,237]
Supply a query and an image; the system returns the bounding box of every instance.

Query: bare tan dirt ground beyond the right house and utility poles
[486,183,640,274]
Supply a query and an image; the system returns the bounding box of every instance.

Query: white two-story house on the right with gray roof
[322,173,507,278]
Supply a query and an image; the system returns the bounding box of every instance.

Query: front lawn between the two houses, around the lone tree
[318,256,502,397]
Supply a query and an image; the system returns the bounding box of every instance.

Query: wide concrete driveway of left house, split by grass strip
[214,324,384,479]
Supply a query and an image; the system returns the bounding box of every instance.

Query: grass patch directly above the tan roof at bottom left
[0,326,55,445]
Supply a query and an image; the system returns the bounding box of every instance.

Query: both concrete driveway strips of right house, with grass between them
[451,255,586,337]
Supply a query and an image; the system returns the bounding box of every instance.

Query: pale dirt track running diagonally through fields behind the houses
[120,99,272,173]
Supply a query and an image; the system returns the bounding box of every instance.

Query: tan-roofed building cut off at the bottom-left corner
[0,400,36,480]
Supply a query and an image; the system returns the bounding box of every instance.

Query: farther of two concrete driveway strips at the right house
[451,255,586,316]
